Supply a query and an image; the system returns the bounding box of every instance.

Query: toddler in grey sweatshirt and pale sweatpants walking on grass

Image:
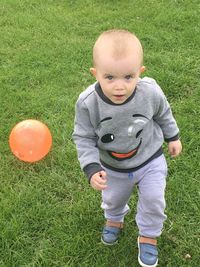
[73,29,182,267]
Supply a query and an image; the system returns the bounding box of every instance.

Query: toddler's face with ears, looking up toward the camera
[90,49,144,104]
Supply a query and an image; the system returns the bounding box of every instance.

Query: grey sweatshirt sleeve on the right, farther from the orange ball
[154,84,179,142]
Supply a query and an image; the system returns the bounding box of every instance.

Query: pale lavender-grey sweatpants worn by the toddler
[101,155,167,238]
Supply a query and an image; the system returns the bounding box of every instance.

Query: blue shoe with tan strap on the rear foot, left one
[101,222,123,246]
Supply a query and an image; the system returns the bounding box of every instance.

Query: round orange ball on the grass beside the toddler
[9,120,52,162]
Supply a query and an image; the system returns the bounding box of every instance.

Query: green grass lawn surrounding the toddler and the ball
[0,0,200,267]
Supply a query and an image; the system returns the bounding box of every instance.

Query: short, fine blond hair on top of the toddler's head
[93,29,143,66]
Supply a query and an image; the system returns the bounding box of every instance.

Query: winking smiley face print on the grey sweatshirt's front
[97,114,149,161]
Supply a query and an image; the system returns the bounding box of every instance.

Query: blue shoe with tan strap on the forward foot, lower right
[138,236,158,267]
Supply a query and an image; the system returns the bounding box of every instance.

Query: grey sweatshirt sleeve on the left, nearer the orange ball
[72,99,103,179]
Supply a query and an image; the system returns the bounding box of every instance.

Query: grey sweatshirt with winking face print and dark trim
[73,77,179,179]
